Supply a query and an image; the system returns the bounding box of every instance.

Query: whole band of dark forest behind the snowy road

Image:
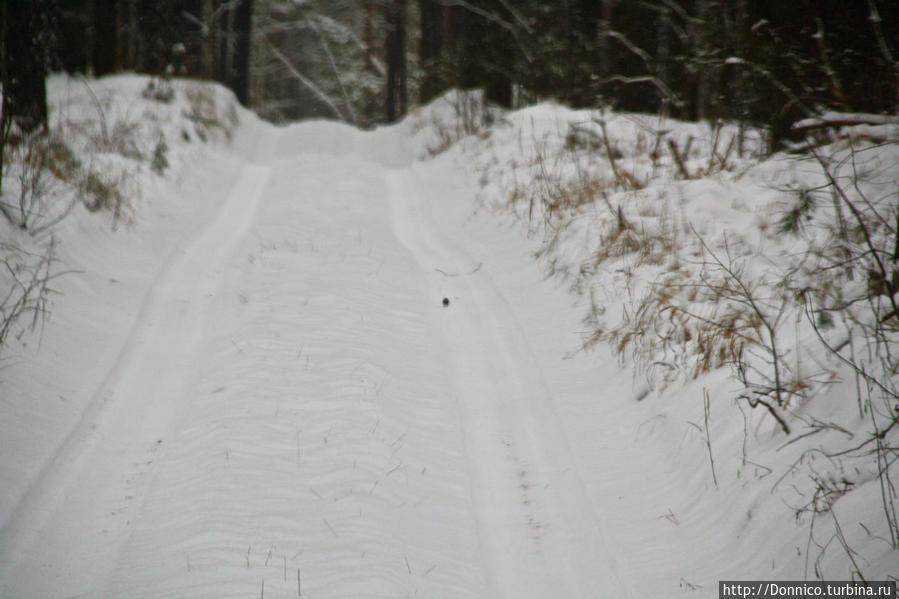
[2,0,899,150]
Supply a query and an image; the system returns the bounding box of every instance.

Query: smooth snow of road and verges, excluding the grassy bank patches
[0,76,899,598]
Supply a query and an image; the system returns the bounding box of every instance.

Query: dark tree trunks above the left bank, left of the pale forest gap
[0,0,253,131]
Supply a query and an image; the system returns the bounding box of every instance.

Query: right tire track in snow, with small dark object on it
[387,165,632,597]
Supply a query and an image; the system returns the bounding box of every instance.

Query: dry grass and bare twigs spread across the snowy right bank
[464,101,899,560]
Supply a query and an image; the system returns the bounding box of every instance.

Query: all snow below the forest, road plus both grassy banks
[0,75,899,597]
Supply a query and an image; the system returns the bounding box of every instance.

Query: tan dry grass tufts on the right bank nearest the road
[472,113,806,407]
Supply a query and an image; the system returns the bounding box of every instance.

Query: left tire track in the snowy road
[0,130,276,597]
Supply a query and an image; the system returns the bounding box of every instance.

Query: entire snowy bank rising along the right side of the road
[424,94,899,578]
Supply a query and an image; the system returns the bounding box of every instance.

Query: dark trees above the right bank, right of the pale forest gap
[419,0,899,142]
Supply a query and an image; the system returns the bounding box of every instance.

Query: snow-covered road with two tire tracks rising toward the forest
[0,118,629,597]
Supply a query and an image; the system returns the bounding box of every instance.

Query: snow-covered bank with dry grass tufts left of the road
[0,75,238,358]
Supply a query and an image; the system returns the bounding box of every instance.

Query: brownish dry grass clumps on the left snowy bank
[0,80,239,235]
